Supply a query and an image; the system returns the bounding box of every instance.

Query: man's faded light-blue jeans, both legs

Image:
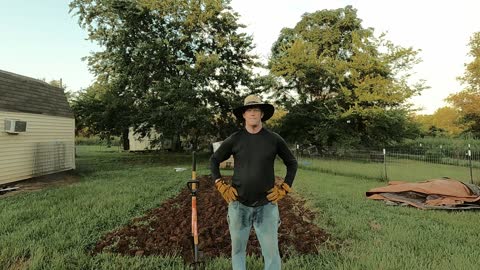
[227,201,281,270]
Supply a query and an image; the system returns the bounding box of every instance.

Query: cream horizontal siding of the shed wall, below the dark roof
[0,109,75,184]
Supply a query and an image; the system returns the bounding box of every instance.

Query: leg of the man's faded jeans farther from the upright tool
[253,203,282,270]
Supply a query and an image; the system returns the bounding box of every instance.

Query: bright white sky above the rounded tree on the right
[232,0,480,113]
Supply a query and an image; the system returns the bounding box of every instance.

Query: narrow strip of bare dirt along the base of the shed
[0,171,79,199]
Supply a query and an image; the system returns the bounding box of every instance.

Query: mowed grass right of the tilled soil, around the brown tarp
[294,170,480,269]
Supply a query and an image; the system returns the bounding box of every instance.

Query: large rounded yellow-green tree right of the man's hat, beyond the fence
[269,6,425,146]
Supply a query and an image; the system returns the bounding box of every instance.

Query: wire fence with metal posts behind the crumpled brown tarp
[293,146,480,184]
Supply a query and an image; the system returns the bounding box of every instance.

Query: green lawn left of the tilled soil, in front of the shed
[0,146,195,269]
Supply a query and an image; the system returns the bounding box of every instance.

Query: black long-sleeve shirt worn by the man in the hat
[210,128,297,206]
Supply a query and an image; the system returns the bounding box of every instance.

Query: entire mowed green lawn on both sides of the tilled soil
[0,146,480,270]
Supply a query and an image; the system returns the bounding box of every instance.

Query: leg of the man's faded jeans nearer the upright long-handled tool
[227,201,253,270]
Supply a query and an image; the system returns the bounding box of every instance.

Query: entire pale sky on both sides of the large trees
[0,0,480,114]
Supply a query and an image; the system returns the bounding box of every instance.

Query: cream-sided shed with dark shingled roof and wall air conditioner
[0,70,75,185]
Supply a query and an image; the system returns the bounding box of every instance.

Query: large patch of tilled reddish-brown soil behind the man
[93,177,329,262]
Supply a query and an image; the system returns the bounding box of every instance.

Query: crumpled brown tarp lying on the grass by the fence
[366,179,480,209]
